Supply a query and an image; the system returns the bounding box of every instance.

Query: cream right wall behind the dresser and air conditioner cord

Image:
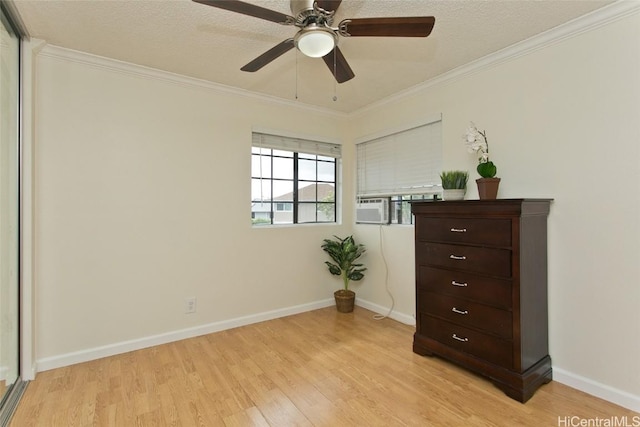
[350,5,640,410]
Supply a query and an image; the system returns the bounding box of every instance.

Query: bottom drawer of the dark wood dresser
[418,313,513,369]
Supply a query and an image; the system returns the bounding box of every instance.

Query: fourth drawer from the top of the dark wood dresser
[418,292,512,338]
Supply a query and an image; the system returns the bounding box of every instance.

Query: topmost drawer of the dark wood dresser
[416,217,511,247]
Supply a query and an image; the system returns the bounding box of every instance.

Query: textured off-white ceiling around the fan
[13,0,611,112]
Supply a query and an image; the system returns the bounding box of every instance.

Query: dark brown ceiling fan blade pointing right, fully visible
[339,16,436,37]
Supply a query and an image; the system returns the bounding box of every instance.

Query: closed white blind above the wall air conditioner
[356,120,442,197]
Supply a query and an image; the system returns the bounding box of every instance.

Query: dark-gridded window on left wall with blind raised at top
[251,133,341,226]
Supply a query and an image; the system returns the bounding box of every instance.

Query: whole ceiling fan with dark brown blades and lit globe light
[193,0,435,83]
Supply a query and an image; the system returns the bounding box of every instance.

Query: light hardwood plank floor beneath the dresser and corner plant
[10,307,640,427]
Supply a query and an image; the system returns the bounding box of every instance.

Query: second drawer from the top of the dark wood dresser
[416,242,511,277]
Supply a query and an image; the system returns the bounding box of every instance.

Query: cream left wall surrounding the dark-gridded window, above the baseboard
[35,47,352,369]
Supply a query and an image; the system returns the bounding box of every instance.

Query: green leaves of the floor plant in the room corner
[321,236,366,291]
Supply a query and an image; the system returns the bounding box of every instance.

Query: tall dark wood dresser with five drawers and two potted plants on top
[411,199,552,402]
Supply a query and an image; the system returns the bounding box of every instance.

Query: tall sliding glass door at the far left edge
[0,2,20,422]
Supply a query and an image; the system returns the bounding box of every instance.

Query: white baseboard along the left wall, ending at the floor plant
[37,298,335,372]
